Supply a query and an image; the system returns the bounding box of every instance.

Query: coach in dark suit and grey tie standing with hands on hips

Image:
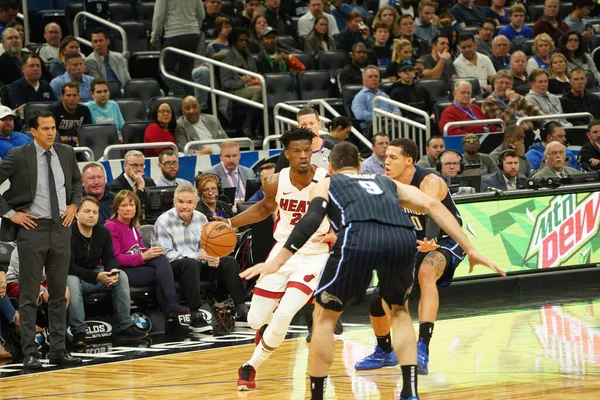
[0,113,82,368]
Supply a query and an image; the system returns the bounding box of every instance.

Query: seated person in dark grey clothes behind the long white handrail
[219,29,262,137]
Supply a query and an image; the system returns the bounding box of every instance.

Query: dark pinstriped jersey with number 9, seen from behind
[329,174,413,231]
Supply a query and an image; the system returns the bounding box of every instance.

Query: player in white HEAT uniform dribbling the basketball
[230,128,335,390]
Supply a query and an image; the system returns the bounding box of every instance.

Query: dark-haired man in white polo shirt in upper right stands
[454,32,496,93]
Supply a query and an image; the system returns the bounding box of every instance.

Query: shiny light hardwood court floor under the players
[0,301,600,400]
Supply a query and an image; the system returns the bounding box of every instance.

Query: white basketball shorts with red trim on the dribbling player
[254,243,329,299]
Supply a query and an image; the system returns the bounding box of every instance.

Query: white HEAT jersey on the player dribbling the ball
[273,167,329,254]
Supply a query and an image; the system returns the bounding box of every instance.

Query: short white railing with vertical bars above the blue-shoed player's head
[371,96,431,149]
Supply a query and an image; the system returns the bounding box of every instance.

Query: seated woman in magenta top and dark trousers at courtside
[104,190,189,318]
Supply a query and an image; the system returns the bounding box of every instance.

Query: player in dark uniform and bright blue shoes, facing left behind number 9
[354,138,502,375]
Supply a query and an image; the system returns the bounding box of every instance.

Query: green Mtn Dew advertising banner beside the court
[455,192,600,277]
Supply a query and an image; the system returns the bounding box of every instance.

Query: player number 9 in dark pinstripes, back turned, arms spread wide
[240,142,500,400]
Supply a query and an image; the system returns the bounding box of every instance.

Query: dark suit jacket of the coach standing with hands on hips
[0,142,82,241]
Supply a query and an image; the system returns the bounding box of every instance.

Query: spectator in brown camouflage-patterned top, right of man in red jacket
[481,70,544,131]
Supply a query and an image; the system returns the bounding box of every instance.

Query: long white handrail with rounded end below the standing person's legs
[159,47,269,137]
